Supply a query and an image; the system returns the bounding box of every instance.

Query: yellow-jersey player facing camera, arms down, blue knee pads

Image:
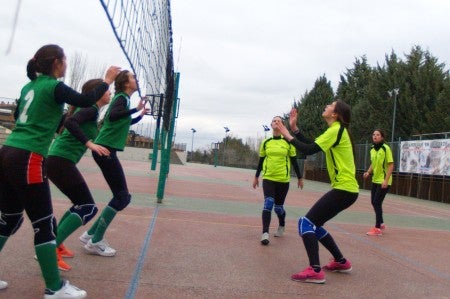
[253,116,303,245]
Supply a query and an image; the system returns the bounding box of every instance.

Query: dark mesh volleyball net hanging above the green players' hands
[100,0,174,129]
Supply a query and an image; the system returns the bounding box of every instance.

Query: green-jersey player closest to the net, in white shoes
[80,70,149,256]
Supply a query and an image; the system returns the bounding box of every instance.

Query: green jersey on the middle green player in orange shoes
[48,105,98,164]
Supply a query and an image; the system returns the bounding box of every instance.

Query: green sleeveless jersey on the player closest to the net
[95,92,131,151]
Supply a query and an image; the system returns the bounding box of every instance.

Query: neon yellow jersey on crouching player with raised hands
[315,121,359,193]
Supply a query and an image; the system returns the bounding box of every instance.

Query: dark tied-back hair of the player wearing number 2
[27,45,65,81]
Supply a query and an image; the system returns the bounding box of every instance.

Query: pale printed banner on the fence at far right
[400,139,450,176]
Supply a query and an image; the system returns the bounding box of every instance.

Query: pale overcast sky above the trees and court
[0,0,450,150]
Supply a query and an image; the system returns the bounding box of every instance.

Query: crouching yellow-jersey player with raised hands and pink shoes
[278,100,359,283]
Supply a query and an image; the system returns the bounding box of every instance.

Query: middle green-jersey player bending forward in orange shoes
[47,79,111,271]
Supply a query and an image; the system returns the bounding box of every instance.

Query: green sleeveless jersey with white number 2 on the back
[4,75,64,157]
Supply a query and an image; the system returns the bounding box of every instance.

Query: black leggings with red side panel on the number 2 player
[0,146,56,245]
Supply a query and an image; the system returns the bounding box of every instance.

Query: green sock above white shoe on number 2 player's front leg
[34,242,62,291]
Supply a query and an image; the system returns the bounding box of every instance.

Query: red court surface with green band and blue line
[0,157,450,299]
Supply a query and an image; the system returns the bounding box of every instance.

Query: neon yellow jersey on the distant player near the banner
[370,143,394,186]
